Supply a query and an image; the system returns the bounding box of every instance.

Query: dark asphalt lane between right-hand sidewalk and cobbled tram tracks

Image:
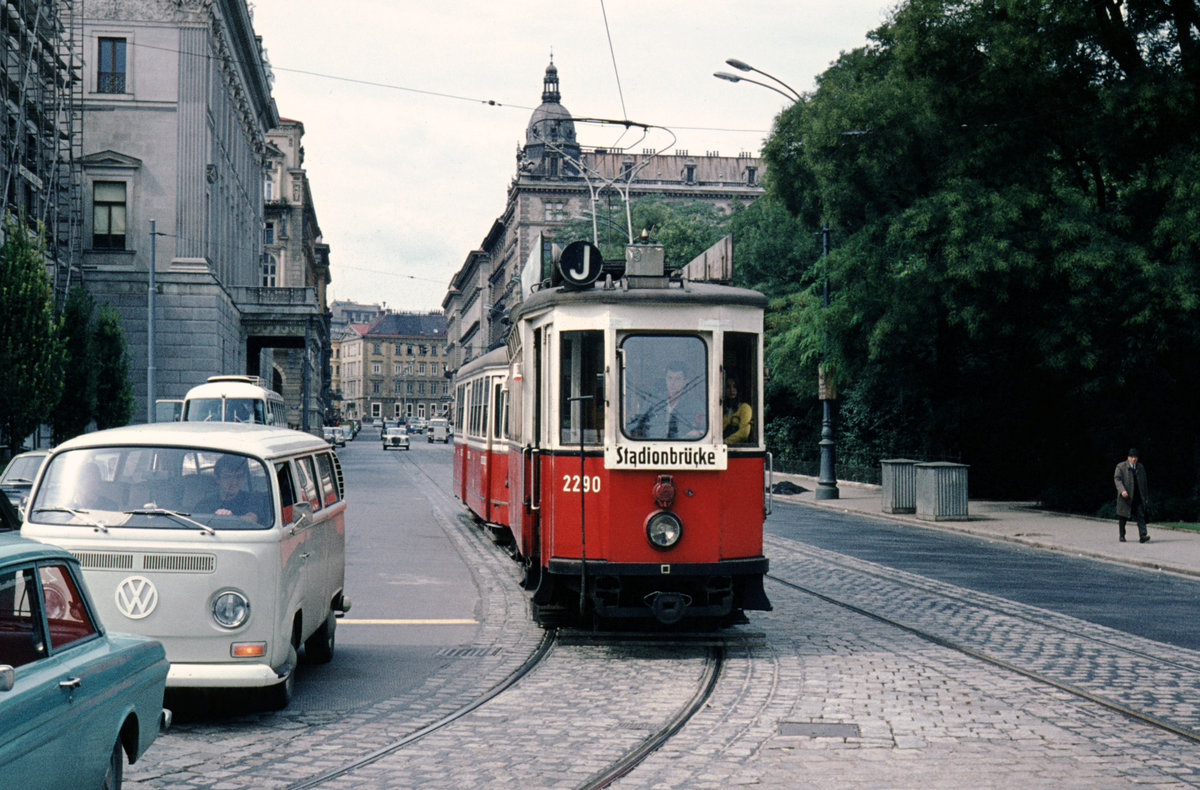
[767,499,1200,650]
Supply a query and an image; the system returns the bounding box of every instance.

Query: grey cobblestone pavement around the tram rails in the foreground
[127,482,1200,790]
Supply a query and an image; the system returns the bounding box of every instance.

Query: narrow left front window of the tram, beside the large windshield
[558,330,605,444]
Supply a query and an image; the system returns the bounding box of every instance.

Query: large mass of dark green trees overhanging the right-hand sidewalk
[764,0,1200,507]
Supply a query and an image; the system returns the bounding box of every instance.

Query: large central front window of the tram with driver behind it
[620,335,708,441]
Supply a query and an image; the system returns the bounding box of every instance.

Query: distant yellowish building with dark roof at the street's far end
[335,312,450,419]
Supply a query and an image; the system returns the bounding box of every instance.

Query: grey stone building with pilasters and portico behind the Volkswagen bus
[80,0,329,430]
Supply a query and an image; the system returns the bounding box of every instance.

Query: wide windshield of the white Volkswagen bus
[30,447,275,529]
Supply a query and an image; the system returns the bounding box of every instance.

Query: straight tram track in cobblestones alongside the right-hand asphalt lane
[767,535,1200,743]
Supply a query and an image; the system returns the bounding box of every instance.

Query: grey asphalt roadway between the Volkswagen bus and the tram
[277,426,479,711]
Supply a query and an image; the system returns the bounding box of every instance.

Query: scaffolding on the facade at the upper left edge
[0,0,84,305]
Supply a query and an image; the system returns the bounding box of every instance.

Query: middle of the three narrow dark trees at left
[52,286,97,444]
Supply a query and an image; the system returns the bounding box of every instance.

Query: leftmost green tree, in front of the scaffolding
[0,215,64,453]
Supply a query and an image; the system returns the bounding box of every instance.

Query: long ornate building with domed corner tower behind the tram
[442,62,763,369]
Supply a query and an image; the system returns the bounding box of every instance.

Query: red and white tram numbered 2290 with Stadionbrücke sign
[454,245,770,627]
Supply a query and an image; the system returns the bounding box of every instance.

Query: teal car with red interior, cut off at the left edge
[0,533,170,790]
